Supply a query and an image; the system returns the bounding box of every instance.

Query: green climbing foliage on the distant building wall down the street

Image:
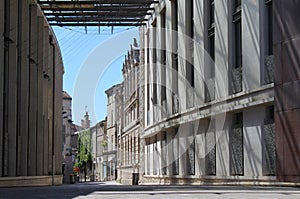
[75,129,92,169]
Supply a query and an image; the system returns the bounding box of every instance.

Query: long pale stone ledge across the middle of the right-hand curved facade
[141,84,274,138]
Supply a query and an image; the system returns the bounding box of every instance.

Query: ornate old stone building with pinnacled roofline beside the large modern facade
[118,39,141,184]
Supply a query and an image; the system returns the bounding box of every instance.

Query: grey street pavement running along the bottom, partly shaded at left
[0,182,300,199]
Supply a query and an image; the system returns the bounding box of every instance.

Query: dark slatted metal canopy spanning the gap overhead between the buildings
[38,0,158,27]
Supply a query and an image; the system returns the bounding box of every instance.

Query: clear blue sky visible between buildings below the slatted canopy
[53,27,138,125]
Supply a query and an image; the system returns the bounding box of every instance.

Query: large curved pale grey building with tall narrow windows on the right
[141,0,276,184]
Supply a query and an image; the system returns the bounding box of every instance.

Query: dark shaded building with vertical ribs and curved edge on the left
[0,0,64,186]
